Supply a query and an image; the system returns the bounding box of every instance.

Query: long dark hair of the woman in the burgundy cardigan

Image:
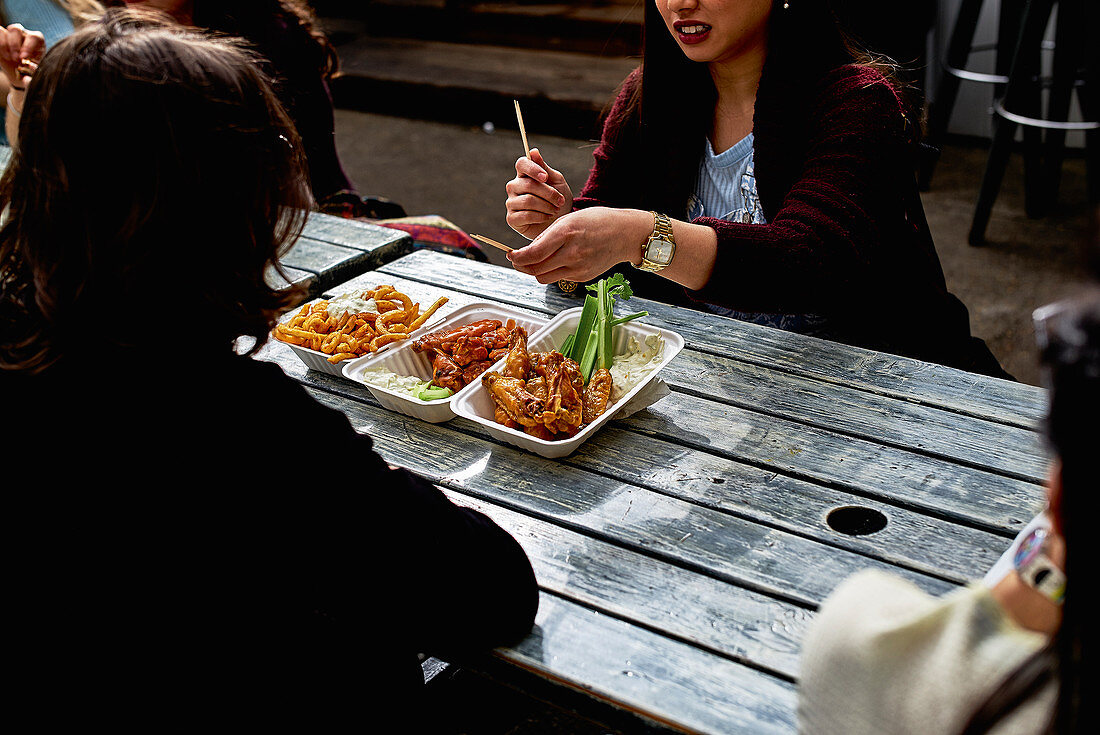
[605,0,910,217]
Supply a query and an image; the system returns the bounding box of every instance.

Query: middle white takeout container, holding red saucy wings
[343,303,547,424]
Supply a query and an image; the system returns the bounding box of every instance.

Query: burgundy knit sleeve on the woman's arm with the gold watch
[690,73,912,312]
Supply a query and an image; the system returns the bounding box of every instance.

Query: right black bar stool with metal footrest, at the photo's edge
[968,0,1100,245]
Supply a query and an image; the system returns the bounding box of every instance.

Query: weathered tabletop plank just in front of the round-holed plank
[297,382,955,606]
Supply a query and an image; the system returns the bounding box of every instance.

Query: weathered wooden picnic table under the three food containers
[251,244,1047,733]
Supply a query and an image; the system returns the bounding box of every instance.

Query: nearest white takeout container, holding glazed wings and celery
[451,307,684,458]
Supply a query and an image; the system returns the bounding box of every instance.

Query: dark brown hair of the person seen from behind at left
[0,9,311,372]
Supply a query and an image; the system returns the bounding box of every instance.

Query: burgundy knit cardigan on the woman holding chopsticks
[573,65,1011,377]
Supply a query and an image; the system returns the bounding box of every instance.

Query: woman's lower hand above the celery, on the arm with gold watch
[508,207,653,283]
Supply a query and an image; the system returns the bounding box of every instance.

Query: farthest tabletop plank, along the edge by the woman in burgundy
[382,252,1046,428]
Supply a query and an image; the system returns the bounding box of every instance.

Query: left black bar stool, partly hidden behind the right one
[917,0,1034,190]
